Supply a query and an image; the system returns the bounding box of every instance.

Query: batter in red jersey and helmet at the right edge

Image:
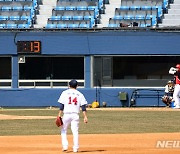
[169,64,180,109]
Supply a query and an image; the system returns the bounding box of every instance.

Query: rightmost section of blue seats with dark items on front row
[109,0,169,27]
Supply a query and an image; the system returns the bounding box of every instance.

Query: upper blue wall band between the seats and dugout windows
[0,31,180,55]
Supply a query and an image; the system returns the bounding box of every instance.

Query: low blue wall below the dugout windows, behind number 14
[0,88,164,107]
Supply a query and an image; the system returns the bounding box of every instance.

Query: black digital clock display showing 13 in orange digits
[17,41,41,54]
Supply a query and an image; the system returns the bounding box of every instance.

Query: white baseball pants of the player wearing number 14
[61,113,79,151]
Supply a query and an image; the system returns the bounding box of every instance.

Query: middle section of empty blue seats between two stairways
[46,0,104,28]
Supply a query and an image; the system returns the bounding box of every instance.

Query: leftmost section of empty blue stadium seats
[0,0,38,29]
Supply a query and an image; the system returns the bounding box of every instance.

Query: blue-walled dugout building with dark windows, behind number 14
[0,29,180,106]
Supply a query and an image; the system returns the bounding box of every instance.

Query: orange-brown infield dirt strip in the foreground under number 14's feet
[0,133,180,154]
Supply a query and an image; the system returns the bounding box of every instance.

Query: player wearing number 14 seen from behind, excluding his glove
[58,80,88,152]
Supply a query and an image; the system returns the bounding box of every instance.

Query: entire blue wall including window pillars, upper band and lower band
[0,31,180,107]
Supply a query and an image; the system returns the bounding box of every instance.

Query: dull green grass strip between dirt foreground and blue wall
[0,109,180,136]
